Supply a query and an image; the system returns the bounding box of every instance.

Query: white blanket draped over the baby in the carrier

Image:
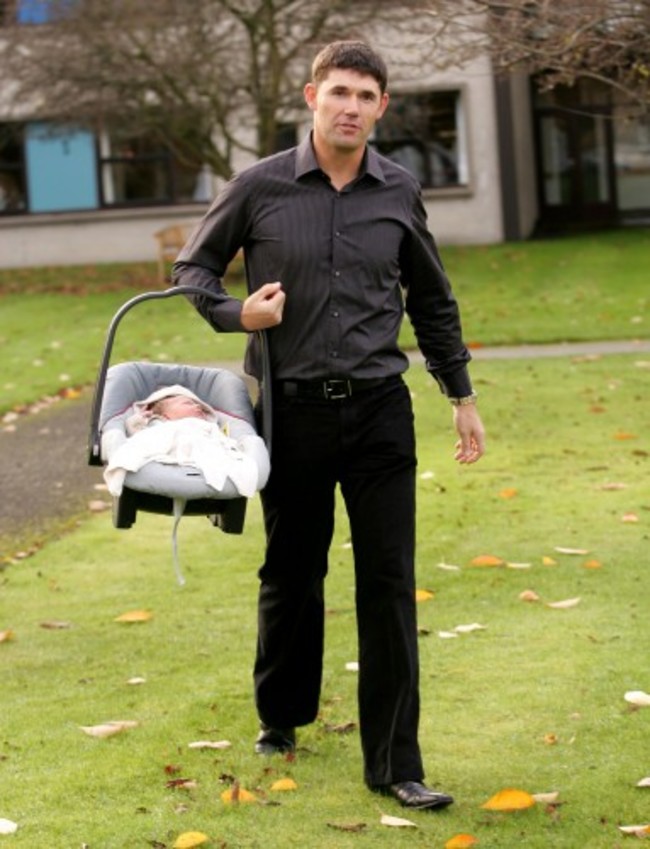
[104,418,258,498]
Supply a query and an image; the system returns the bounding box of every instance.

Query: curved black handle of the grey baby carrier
[88,286,272,466]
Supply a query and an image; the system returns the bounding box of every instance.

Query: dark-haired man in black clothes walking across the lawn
[174,41,484,809]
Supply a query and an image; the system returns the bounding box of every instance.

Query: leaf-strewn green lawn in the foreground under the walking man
[0,356,650,849]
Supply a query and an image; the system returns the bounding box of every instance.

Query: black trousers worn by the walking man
[254,377,423,786]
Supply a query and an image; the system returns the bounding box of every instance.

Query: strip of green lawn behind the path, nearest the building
[0,229,650,414]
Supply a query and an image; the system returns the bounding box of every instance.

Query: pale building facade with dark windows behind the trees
[0,0,650,268]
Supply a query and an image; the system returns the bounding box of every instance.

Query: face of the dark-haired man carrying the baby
[305,68,388,151]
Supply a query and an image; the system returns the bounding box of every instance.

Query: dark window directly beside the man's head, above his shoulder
[373,91,468,189]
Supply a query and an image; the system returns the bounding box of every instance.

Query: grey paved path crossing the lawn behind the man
[0,340,650,568]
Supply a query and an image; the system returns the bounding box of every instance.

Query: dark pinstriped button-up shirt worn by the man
[173,137,471,396]
